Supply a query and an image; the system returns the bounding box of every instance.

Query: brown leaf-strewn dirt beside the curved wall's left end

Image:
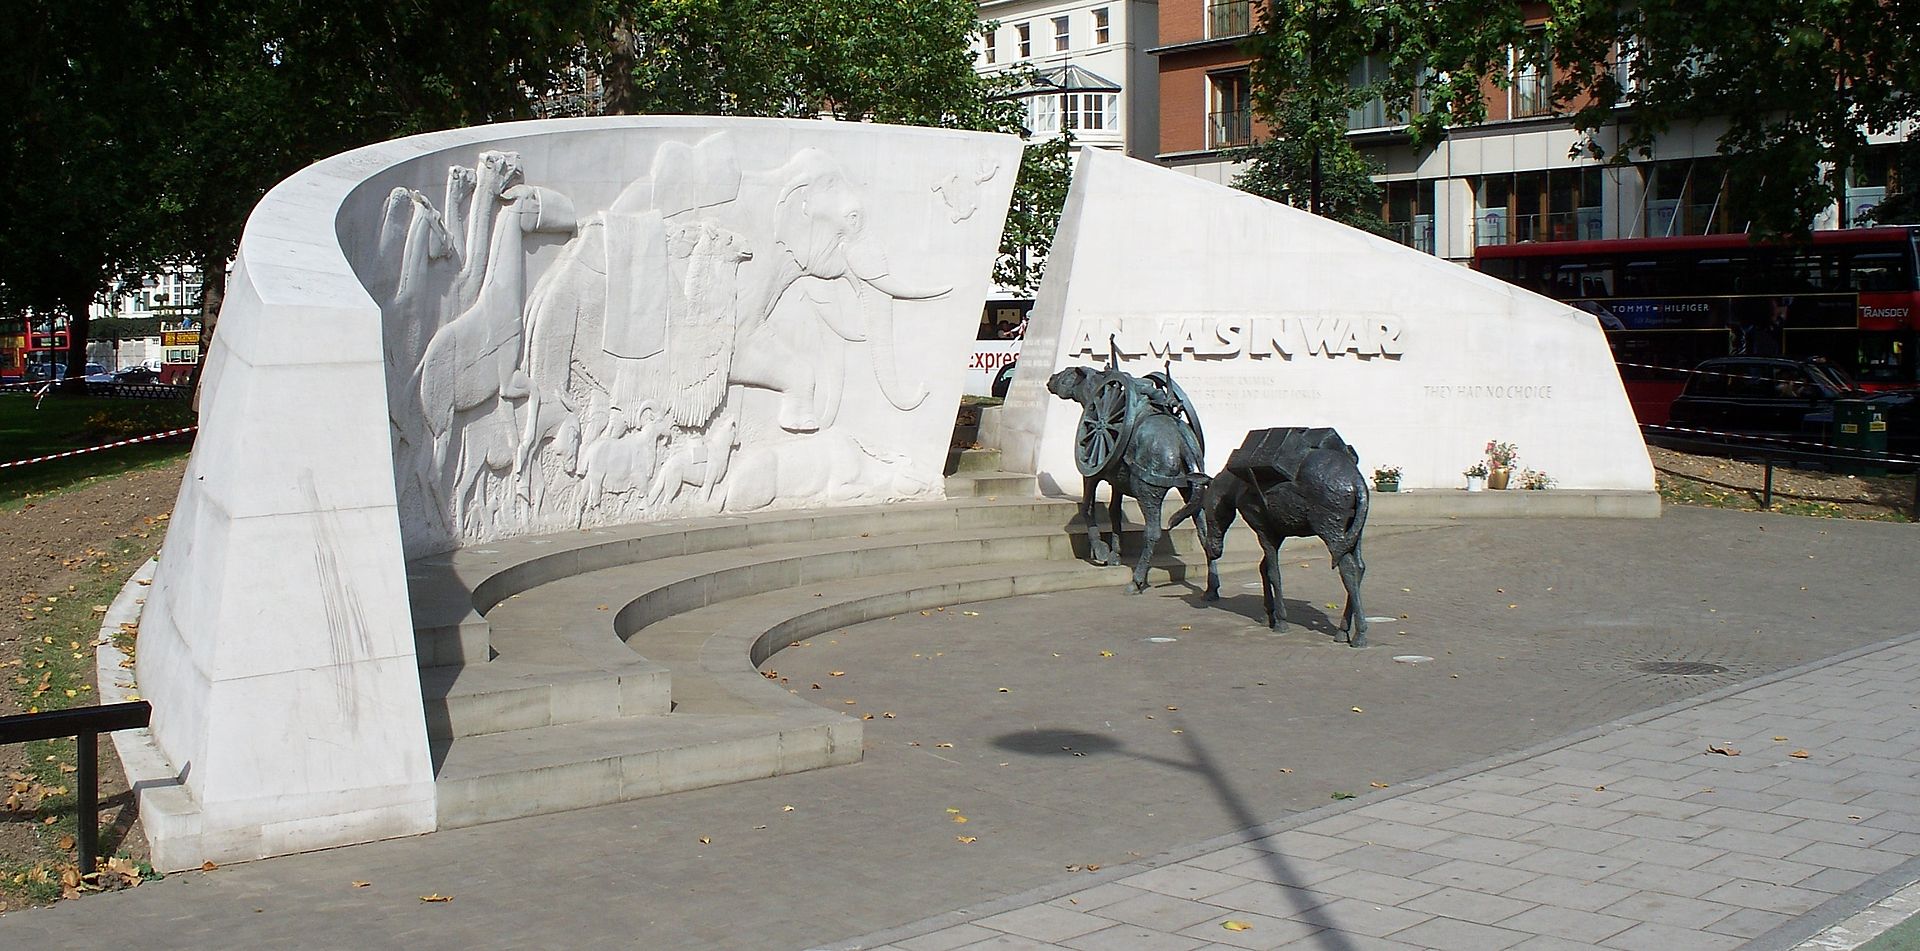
[0,459,186,907]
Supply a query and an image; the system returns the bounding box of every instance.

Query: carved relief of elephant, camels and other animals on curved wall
[369,133,998,553]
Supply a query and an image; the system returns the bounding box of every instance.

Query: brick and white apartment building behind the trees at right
[1150,0,1897,261]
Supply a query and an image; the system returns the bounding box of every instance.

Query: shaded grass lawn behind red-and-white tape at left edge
[0,392,194,509]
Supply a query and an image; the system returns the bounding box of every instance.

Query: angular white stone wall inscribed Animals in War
[998,150,1653,494]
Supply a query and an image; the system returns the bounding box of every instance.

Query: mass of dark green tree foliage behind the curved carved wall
[0,0,1052,386]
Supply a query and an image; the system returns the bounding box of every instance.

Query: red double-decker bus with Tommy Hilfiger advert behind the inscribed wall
[1473,227,1920,423]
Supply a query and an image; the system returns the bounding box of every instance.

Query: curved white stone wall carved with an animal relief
[138,117,1020,868]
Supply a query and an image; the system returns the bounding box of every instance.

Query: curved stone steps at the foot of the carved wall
[409,474,1260,828]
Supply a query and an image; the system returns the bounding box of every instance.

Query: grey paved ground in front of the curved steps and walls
[0,509,1920,951]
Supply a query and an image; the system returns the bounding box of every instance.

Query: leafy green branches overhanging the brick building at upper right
[1254,0,1920,232]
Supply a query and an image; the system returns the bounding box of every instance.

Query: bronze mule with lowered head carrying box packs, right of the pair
[1167,428,1369,647]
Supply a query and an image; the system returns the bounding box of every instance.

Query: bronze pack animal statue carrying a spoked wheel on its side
[1046,367,1212,594]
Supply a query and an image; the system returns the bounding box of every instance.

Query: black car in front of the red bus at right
[1668,357,1920,451]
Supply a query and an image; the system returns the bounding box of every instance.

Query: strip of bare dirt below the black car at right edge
[1647,446,1914,521]
